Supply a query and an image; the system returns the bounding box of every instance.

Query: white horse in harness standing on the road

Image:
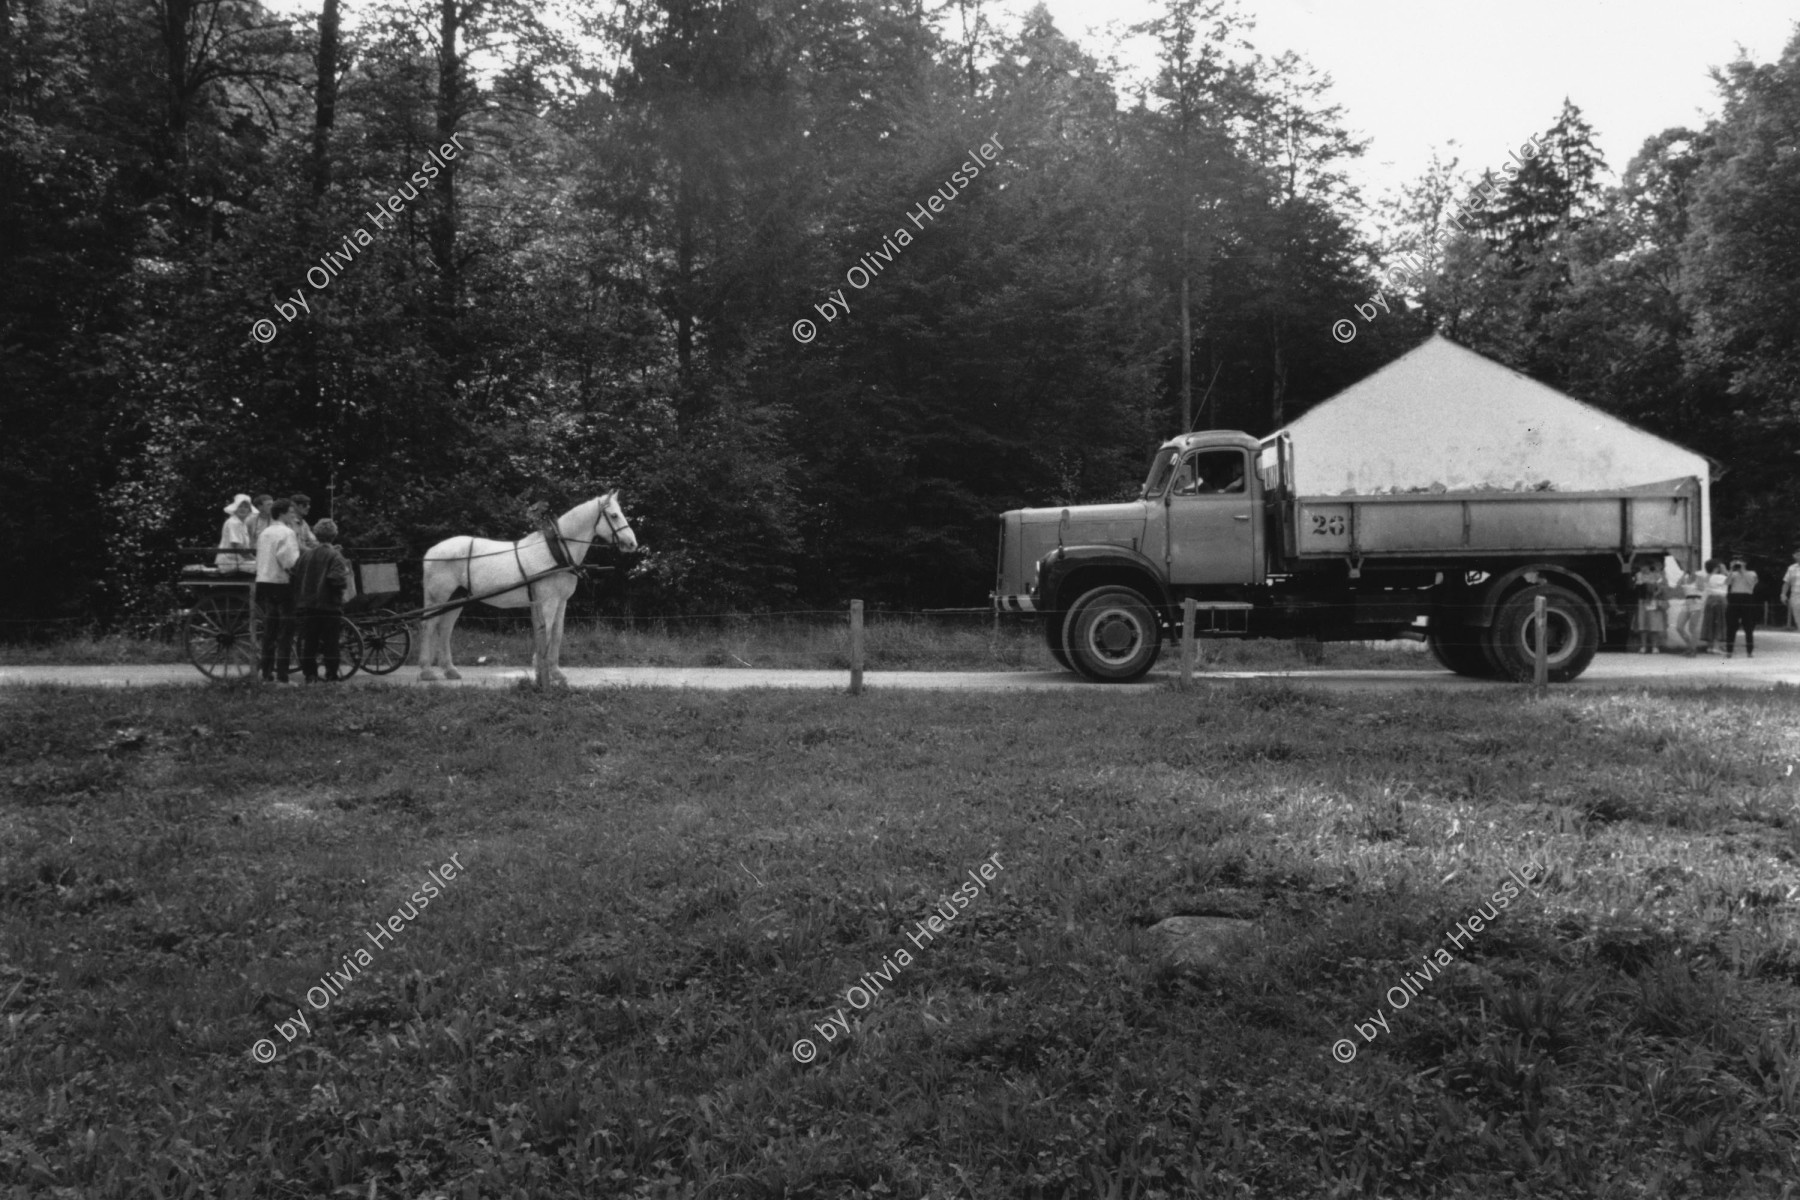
[419,488,637,684]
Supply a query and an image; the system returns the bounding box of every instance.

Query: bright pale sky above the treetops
[1029,0,1800,213]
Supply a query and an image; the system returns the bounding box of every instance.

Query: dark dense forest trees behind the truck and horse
[0,0,1800,619]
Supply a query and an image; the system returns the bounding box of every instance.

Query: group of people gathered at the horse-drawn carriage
[212,491,356,684]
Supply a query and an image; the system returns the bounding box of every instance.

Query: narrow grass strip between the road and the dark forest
[0,615,1438,671]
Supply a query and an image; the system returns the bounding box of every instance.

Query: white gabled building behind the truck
[1287,336,1712,558]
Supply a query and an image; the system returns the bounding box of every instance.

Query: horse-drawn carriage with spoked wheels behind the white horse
[175,547,412,682]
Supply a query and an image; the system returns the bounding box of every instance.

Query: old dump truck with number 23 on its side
[992,430,1703,682]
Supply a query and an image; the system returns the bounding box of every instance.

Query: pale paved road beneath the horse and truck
[0,631,1800,691]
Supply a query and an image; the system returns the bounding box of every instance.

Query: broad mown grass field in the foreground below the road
[0,684,1800,1200]
